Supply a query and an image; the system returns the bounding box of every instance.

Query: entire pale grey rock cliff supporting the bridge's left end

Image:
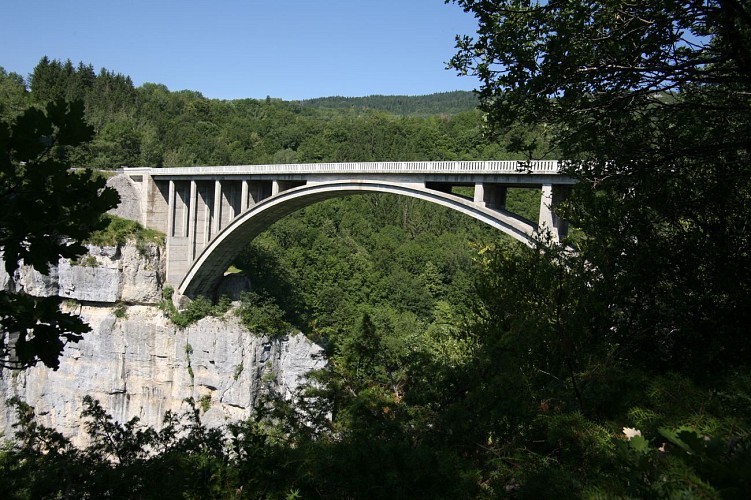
[0,241,326,444]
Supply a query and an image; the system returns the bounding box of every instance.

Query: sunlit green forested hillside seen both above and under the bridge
[0,57,539,356]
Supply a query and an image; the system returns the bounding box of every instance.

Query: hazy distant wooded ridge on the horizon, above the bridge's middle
[292,90,479,116]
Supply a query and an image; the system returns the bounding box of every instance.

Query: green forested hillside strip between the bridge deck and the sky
[0,57,540,169]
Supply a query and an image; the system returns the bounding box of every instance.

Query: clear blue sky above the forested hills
[0,0,478,100]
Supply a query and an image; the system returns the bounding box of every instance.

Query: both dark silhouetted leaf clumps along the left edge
[0,101,119,368]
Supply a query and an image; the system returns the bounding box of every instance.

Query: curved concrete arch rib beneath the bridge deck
[178,180,537,297]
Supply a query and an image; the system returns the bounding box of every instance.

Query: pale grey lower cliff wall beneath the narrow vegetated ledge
[0,306,325,443]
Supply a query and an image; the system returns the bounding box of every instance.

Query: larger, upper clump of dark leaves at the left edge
[0,102,119,274]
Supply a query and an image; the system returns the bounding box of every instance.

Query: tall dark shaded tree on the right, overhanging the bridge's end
[451,0,751,376]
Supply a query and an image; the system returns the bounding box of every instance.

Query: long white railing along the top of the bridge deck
[138,160,560,176]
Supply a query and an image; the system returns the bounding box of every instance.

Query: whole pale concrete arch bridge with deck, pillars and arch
[123,161,575,296]
